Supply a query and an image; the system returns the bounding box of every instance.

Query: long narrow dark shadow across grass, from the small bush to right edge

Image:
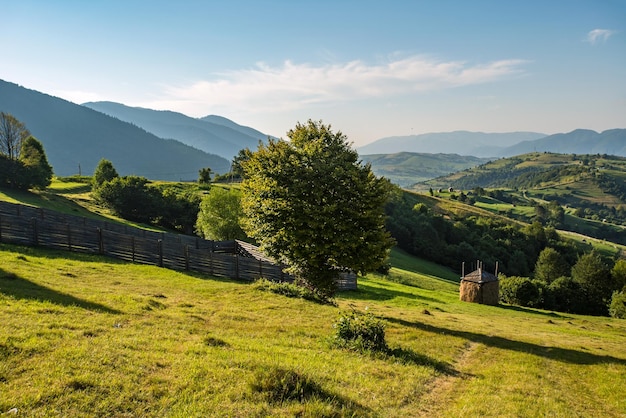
[384,317,626,365]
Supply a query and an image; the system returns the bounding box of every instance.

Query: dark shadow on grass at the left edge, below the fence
[0,268,122,314]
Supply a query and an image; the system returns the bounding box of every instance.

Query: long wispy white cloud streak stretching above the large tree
[139,56,526,114]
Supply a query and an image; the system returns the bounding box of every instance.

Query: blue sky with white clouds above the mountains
[0,0,626,147]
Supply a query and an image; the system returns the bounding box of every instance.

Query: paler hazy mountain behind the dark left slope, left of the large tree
[83,102,267,160]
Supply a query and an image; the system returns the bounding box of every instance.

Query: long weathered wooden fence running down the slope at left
[0,202,356,290]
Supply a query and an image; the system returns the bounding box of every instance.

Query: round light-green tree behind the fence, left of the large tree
[196,187,246,240]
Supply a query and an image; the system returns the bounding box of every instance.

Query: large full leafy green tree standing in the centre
[241,120,393,295]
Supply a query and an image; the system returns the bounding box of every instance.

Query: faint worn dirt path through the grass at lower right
[418,342,479,418]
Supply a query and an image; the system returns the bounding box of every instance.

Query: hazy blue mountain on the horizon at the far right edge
[499,129,626,157]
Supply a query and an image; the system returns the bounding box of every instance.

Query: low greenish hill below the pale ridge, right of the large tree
[361,152,488,187]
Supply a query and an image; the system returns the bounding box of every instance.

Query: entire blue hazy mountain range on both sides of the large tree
[0,80,626,185]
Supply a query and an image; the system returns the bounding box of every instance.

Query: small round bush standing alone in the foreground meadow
[333,310,388,352]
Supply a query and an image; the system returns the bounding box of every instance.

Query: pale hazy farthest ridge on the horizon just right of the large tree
[357,131,546,157]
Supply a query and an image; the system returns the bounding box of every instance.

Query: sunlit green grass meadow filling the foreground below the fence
[0,244,626,417]
